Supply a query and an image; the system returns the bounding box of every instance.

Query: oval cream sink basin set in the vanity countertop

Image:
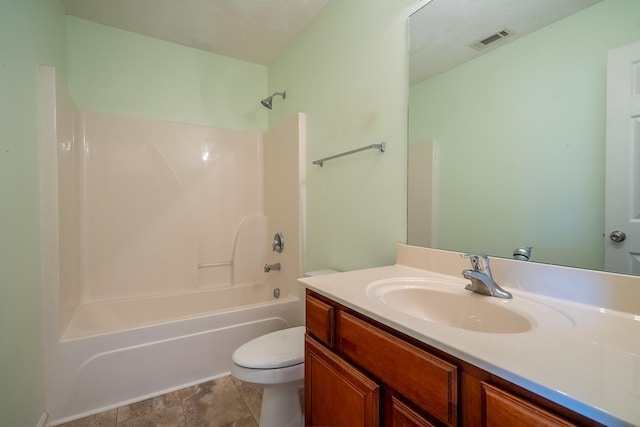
[367,277,535,334]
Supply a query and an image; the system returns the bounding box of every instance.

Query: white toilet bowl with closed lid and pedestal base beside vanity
[231,326,305,427]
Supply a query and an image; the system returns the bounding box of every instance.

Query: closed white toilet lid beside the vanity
[231,326,305,369]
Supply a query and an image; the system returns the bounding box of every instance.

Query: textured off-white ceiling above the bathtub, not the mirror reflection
[62,0,329,65]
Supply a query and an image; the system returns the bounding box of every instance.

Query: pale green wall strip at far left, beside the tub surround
[0,0,65,426]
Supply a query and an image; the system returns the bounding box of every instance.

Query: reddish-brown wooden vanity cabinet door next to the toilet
[305,336,380,427]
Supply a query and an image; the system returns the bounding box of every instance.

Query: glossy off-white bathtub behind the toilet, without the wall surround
[47,285,302,425]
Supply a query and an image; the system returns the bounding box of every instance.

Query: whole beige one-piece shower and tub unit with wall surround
[40,67,304,425]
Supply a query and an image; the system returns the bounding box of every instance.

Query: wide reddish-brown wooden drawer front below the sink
[338,311,458,426]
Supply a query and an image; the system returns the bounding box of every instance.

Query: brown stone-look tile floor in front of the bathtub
[59,376,262,427]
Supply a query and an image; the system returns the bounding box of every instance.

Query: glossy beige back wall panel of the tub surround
[80,112,267,302]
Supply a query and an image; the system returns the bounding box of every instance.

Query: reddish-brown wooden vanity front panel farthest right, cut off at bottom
[482,382,575,427]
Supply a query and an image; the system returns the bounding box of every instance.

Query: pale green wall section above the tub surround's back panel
[67,16,267,131]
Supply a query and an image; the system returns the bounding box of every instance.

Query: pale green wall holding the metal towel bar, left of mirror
[269,0,417,270]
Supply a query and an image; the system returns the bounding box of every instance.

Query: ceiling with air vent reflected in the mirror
[409,0,602,84]
